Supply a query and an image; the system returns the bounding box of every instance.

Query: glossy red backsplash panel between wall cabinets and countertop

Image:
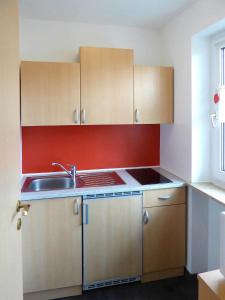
[22,125,160,173]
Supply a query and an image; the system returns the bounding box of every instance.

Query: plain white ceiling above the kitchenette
[19,0,197,28]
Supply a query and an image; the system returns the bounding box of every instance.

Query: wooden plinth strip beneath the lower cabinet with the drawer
[141,267,184,283]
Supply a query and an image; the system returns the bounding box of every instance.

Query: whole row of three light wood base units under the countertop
[22,188,186,300]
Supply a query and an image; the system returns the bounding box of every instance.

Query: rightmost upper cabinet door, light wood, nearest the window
[134,66,173,124]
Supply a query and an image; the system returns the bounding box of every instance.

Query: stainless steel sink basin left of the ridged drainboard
[22,177,74,192]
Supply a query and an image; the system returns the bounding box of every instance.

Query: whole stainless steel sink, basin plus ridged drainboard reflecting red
[22,172,126,192]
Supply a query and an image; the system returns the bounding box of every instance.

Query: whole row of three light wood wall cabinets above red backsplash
[21,47,173,126]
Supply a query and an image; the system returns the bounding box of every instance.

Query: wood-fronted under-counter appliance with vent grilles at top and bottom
[82,191,143,290]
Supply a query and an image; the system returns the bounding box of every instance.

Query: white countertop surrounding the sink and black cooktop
[21,167,186,201]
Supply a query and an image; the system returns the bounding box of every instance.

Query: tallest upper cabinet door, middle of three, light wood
[80,47,133,125]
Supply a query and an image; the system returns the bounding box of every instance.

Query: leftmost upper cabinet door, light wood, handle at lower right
[21,62,80,126]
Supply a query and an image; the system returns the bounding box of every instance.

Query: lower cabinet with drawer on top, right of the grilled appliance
[142,188,186,281]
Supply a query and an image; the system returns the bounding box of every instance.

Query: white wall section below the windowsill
[187,188,225,273]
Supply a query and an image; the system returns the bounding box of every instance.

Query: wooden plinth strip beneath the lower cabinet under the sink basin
[23,286,82,300]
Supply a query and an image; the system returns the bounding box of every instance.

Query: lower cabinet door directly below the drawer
[143,204,186,274]
